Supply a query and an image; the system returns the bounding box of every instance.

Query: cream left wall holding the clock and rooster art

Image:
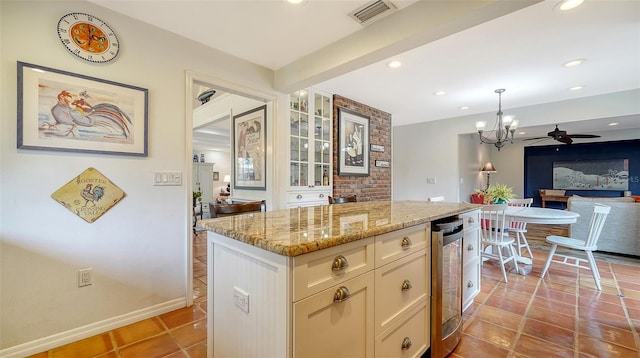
[0,1,273,355]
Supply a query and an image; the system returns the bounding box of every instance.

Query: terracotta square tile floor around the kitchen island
[32,229,640,358]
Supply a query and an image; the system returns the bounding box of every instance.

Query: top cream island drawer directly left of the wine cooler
[376,224,431,267]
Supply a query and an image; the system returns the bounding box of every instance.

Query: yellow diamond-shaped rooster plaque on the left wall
[51,168,126,223]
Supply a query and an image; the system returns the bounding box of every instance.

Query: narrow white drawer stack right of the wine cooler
[460,210,482,311]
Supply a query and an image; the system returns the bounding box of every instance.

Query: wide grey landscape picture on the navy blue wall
[553,159,629,191]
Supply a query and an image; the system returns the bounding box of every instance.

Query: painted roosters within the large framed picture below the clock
[38,89,133,143]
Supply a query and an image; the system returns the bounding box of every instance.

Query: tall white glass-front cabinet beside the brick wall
[287,89,333,207]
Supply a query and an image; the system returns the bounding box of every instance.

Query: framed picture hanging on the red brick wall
[338,108,370,176]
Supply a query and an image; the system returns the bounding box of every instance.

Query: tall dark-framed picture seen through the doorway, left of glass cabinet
[233,105,267,190]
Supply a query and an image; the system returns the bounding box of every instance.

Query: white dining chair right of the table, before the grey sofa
[540,204,611,291]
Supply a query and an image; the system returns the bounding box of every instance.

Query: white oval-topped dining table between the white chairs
[490,206,580,274]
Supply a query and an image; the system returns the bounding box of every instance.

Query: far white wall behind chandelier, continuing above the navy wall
[392,90,640,201]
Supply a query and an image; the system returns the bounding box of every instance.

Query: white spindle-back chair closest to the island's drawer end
[480,204,518,282]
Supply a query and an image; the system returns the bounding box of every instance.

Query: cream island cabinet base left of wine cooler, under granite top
[207,224,431,357]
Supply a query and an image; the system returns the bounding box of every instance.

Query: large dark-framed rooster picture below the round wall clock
[18,62,149,156]
